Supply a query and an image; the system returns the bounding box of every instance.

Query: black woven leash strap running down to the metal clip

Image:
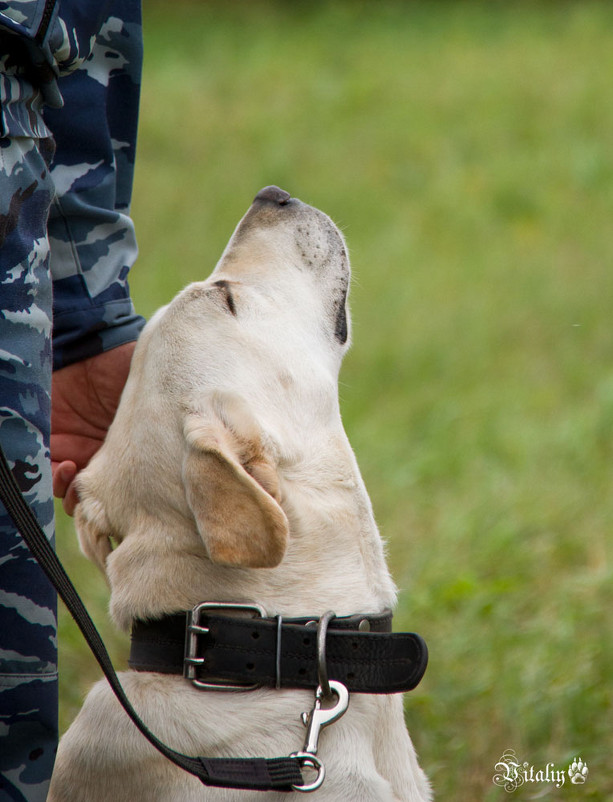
[0,446,304,791]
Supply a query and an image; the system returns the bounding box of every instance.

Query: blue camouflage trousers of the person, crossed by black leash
[0,137,57,802]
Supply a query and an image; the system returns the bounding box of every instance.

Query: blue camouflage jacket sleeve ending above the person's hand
[44,0,144,368]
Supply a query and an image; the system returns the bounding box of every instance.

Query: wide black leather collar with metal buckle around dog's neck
[129,610,428,693]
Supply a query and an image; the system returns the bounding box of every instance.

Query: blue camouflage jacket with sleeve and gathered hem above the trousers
[0,0,144,368]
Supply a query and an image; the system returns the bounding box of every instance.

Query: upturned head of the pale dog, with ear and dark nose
[76,187,349,568]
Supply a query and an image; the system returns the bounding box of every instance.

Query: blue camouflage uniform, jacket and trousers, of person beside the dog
[0,0,144,802]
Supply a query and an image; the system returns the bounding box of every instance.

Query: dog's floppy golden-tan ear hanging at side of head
[183,393,289,568]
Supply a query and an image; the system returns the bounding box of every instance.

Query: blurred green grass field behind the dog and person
[58,0,613,802]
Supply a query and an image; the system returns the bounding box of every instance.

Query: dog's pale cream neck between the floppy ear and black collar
[107,437,395,629]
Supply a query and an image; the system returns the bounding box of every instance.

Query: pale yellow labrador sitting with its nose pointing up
[49,187,430,802]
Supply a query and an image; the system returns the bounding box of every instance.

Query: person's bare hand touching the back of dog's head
[51,342,136,515]
